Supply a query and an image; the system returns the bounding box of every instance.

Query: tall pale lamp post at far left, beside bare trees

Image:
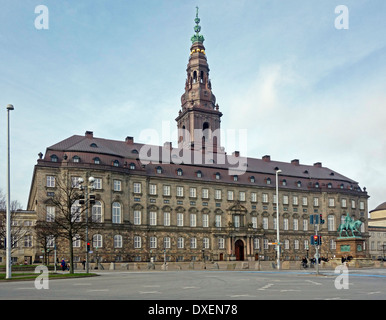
[5,104,14,279]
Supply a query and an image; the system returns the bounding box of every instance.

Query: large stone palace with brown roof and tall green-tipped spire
[28,10,368,261]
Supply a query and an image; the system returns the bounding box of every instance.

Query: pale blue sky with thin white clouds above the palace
[0,0,386,210]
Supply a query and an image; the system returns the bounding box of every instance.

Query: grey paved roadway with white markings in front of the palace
[0,269,386,301]
